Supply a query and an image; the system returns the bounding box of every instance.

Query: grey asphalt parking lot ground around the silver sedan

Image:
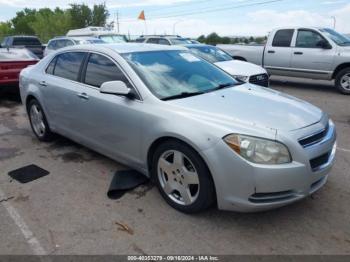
[0,78,350,254]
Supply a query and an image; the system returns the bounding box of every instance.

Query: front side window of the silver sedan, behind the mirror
[84,54,129,87]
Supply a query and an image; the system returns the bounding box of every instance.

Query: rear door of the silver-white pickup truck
[264,29,295,74]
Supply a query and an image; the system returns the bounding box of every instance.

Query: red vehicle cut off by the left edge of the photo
[0,48,39,86]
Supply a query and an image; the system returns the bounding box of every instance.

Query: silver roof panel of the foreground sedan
[60,43,187,54]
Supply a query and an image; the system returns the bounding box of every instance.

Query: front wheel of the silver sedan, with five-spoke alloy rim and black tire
[151,140,215,214]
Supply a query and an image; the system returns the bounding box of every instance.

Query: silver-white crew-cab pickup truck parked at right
[218,27,350,95]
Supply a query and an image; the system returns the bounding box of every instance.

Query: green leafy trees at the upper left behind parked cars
[0,3,109,42]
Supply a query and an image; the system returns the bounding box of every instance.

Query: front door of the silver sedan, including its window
[79,53,143,164]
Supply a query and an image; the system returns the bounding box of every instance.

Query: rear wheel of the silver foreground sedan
[27,99,54,142]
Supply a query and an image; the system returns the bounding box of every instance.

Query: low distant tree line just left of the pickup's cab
[197,33,267,45]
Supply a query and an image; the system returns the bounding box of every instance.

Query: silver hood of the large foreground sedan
[169,84,323,131]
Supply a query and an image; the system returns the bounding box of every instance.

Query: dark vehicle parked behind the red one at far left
[1,36,44,59]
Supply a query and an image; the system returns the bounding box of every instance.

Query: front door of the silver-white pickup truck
[291,29,336,79]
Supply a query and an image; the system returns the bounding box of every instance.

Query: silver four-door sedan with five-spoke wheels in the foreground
[20,44,336,213]
